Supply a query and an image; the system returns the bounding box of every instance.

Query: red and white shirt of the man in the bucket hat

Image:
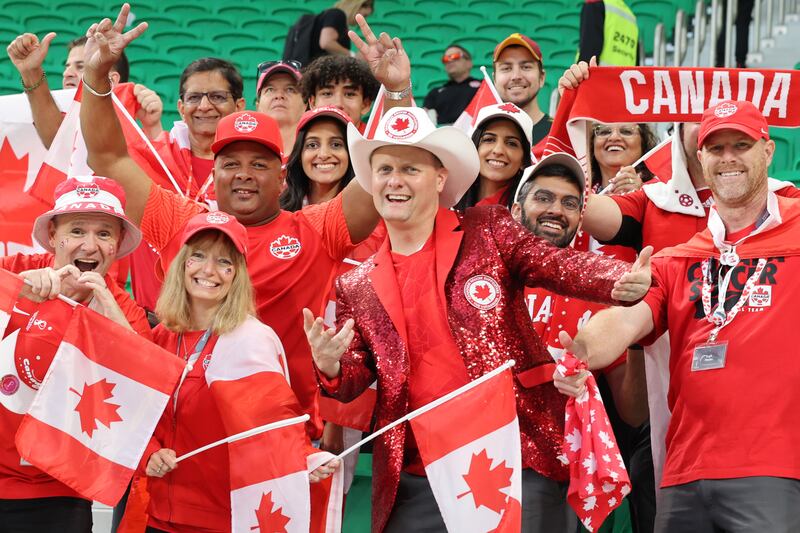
[0,254,150,499]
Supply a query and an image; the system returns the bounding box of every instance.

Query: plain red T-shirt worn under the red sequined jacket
[392,236,470,476]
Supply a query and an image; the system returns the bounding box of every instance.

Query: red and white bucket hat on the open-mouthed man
[33,176,142,259]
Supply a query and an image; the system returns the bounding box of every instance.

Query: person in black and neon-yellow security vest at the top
[578,0,639,67]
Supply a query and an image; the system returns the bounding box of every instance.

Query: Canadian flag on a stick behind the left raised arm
[26,83,181,205]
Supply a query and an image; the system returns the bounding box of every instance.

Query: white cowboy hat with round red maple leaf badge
[347,107,480,207]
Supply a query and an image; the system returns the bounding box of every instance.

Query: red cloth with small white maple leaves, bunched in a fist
[556,352,631,532]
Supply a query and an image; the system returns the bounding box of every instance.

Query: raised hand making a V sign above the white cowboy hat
[348,15,411,92]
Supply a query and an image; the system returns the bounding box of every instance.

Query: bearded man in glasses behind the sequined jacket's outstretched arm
[511,153,655,532]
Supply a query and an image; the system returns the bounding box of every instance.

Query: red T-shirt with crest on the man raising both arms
[141,186,353,439]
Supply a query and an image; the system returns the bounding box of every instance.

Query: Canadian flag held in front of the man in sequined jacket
[410,368,522,533]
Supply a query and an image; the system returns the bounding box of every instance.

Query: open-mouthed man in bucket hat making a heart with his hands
[0,177,150,533]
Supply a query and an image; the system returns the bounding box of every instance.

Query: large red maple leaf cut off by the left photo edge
[0,138,48,246]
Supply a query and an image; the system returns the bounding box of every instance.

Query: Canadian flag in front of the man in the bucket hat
[16,306,184,505]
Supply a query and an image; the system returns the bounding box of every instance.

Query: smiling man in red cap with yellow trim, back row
[494,33,553,145]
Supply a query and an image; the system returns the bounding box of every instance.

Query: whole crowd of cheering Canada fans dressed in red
[0,0,800,533]
